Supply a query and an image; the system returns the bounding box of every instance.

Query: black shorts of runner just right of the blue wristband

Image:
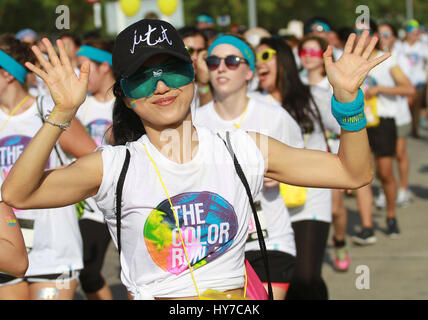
[367,118,397,157]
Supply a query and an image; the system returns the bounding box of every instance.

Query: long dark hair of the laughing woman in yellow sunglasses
[259,36,322,134]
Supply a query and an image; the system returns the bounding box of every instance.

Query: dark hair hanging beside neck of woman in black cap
[112,79,146,145]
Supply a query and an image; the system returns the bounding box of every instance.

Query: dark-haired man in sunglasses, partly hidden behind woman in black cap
[178,26,213,105]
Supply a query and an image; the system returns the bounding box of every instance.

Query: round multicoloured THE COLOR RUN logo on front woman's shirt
[144,191,238,274]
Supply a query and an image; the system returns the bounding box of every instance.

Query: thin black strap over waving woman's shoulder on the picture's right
[217,131,273,300]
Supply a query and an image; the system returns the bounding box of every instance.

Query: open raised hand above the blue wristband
[324,30,391,103]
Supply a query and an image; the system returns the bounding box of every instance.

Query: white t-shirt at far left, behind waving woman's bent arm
[0,97,83,276]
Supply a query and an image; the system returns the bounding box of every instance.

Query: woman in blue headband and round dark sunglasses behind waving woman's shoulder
[194,34,303,300]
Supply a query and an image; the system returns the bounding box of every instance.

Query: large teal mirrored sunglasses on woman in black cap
[120,61,194,99]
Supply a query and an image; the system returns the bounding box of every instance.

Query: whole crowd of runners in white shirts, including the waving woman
[0,10,428,300]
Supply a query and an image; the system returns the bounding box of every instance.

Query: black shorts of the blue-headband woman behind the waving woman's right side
[245,250,296,283]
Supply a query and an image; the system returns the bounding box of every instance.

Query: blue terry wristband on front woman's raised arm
[331,89,367,131]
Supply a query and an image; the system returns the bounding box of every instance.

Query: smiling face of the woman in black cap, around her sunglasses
[124,54,194,130]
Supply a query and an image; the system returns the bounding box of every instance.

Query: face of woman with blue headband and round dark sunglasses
[209,44,253,96]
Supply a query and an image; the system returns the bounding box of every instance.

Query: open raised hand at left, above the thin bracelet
[25,38,89,120]
